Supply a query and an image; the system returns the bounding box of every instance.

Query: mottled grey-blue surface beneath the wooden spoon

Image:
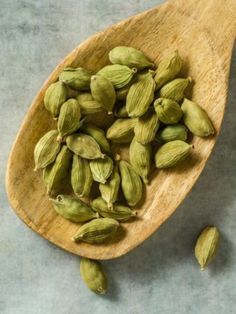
[0,0,236,314]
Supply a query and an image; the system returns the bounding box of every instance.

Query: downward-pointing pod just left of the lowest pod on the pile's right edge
[129,138,152,184]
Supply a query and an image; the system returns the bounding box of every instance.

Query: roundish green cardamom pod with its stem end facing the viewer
[154,98,183,124]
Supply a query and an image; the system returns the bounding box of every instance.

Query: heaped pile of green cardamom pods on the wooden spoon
[34,46,214,293]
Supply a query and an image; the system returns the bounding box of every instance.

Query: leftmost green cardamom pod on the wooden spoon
[34,130,61,170]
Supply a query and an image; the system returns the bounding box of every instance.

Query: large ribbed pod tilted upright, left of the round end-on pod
[126,72,155,117]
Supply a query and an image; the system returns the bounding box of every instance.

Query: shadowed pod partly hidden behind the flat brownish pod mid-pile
[81,123,111,154]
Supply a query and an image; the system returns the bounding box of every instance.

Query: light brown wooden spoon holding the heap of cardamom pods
[6,0,236,259]
